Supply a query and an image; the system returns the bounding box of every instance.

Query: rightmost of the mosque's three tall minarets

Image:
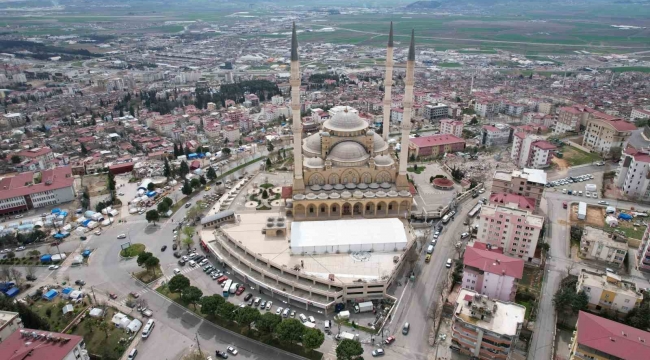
[395,30,415,190]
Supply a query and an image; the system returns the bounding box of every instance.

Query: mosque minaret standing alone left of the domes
[289,23,305,193]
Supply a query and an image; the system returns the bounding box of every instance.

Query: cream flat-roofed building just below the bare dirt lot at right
[579,226,627,268]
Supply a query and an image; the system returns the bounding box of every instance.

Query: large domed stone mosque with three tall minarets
[287,24,415,220]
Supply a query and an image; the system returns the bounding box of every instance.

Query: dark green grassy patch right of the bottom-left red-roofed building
[71,308,129,360]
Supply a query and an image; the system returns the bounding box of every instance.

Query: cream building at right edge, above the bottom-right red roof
[576,269,643,314]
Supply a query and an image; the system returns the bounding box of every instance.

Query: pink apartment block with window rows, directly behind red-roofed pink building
[476,204,544,261]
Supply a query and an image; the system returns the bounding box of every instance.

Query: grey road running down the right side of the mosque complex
[386,199,476,360]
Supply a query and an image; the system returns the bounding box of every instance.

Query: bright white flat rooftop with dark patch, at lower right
[454,289,526,336]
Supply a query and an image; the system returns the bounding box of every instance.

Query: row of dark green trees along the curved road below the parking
[156,275,325,360]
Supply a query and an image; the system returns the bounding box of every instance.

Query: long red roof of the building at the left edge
[0,166,74,200]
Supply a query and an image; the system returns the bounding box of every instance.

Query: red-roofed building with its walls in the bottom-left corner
[0,329,90,360]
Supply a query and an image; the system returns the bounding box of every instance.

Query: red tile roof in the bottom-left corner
[0,329,83,360]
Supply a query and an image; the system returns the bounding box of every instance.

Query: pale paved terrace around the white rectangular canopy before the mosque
[221,212,410,284]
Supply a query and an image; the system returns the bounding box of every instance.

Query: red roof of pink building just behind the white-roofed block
[463,246,524,279]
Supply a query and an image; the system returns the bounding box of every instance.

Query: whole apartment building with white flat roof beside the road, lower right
[451,289,526,360]
